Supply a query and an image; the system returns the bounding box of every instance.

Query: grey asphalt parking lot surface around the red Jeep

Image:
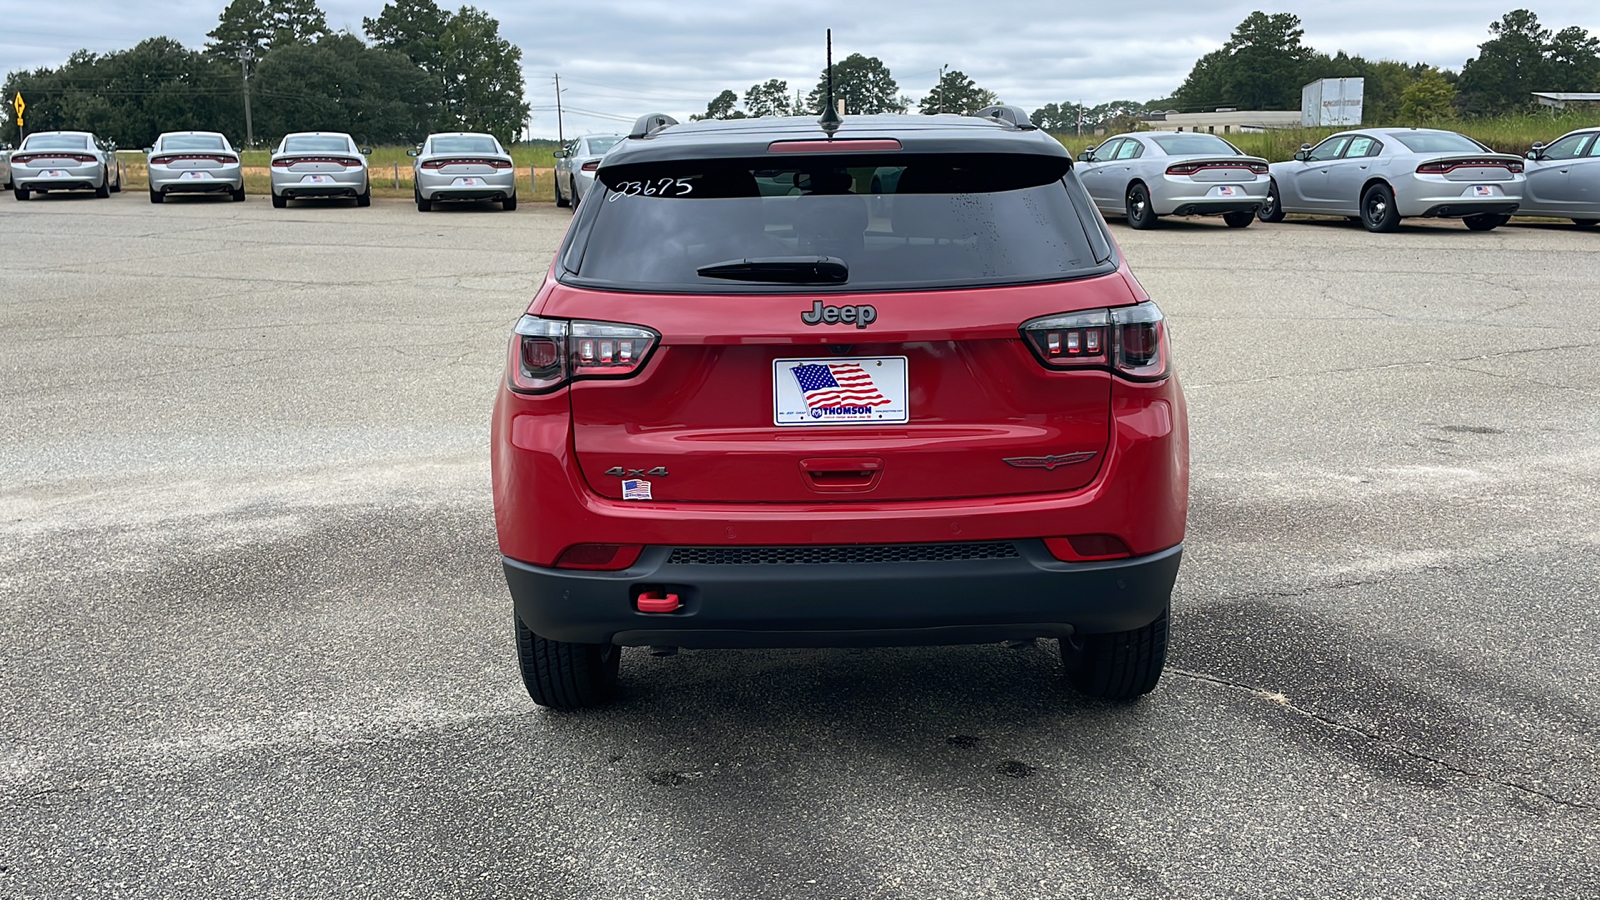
[0,195,1600,898]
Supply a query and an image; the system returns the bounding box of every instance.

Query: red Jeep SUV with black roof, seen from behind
[493,107,1189,708]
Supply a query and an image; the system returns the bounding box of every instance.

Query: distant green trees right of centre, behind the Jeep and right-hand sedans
[694,10,1600,133]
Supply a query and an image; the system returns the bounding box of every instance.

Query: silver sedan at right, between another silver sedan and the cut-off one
[1261,128,1526,231]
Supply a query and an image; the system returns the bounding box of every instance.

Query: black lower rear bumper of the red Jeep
[504,540,1182,647]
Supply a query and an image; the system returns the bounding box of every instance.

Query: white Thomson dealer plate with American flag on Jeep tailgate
[773,356,910,426]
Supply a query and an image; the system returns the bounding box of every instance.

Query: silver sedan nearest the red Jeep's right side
[1077,131,1267,229]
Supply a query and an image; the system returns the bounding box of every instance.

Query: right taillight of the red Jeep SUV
[1021,301,1168,381]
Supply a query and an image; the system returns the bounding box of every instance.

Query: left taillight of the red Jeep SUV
[512,315,661,394]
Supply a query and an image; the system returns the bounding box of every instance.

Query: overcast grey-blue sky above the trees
[0,0,1600,136]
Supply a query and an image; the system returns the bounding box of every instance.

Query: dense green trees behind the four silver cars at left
[3,0,528,147]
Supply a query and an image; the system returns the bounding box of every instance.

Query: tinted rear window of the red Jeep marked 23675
[562,154,1112,293]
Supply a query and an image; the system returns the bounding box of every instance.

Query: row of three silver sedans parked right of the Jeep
[1078,128,1600,232]
